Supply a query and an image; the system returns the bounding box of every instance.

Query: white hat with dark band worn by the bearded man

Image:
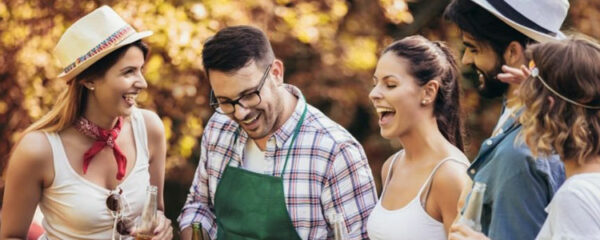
[472,0,569,42]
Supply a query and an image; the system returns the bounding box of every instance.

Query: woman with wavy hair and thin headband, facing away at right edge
[519,35,600,239]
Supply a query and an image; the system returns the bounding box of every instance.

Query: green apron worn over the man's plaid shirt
[214,106,307,240]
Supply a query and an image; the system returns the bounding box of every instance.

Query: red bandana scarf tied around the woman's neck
[75,117,127,180]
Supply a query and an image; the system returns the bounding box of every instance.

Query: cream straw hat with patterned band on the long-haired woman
[54,6,152,80]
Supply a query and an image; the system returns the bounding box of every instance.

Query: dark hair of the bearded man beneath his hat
[444,0,535,56]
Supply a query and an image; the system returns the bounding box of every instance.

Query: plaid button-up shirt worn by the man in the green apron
[178,85,377,239]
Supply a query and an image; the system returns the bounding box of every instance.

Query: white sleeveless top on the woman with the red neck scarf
[39,108,150,240]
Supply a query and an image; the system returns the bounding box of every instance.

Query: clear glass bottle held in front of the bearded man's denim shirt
[458,182,486,232]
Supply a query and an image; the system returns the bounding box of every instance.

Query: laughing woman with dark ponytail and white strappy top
[367,36,469,239]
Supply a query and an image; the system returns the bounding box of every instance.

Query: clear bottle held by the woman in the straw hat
[135,185,158,240]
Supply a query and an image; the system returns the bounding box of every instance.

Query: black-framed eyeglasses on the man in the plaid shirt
[210,64,272,114]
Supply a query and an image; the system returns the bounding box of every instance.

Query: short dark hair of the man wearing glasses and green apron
[202,26,275,73]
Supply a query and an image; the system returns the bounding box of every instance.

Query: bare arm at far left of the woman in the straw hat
[0,132,54,239]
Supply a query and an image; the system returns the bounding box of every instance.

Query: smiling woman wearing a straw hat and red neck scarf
[0,6,172,239]
